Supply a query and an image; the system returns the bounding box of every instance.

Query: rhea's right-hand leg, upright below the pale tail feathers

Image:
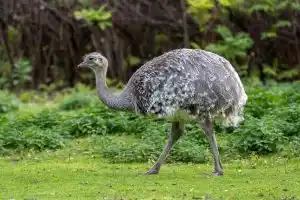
[200,117,223,176]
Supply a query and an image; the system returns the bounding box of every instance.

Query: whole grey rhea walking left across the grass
[78,48,248,176]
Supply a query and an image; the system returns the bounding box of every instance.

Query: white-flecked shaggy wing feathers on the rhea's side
[130,62,193,114]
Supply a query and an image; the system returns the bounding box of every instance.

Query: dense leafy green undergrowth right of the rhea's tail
[226,84,300,154]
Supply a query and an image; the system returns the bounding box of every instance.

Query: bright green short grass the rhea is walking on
[0,138,300,200]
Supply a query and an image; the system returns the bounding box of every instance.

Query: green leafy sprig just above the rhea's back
[205,26,253,64]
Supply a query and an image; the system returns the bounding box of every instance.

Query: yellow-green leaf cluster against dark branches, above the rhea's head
[74,6,112,30]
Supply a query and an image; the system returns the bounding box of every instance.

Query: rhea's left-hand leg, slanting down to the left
[145,121,184,175]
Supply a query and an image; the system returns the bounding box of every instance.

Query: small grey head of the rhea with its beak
[77,52,108,71]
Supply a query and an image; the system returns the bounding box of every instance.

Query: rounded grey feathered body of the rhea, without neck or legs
[125,49,247,126]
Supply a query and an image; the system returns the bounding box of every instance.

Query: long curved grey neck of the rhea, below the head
[94,70,133,110]
